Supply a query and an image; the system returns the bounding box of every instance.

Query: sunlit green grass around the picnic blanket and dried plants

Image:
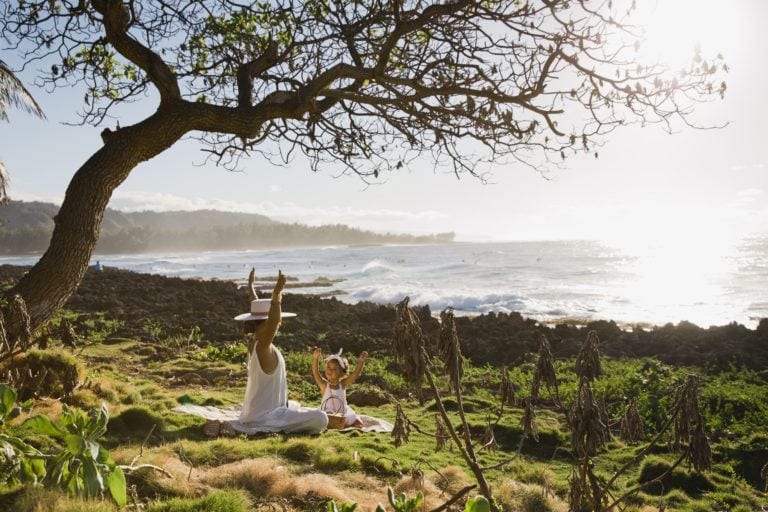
[0,324,768,512]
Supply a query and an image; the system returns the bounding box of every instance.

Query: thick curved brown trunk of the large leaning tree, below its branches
[6,108,190,339]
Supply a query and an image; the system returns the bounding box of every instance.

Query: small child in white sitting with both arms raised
[312,347,368,428]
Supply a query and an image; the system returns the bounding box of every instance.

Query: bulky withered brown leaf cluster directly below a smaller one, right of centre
[568,378,609,458]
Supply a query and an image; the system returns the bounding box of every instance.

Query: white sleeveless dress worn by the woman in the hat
[230,345,328,434]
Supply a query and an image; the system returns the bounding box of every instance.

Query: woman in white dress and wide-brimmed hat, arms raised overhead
[221,270,328,434]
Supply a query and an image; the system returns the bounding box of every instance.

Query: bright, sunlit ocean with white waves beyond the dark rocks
[0,237,768,327]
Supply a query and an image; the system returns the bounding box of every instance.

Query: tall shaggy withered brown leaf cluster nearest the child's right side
[392,297,426,404]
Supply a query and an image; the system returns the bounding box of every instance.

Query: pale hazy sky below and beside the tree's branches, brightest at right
[0,0,768,244]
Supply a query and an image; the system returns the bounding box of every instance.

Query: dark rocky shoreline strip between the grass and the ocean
[0,265,768,370]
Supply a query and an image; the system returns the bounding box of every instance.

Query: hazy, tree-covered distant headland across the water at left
[0,201,455,256]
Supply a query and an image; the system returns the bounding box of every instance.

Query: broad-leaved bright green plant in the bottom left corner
[22,405,127,506]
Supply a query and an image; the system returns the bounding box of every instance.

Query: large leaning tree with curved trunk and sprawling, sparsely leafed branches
[0,0,725,342]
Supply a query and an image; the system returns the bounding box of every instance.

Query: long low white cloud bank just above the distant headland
[109,190,447,231]
